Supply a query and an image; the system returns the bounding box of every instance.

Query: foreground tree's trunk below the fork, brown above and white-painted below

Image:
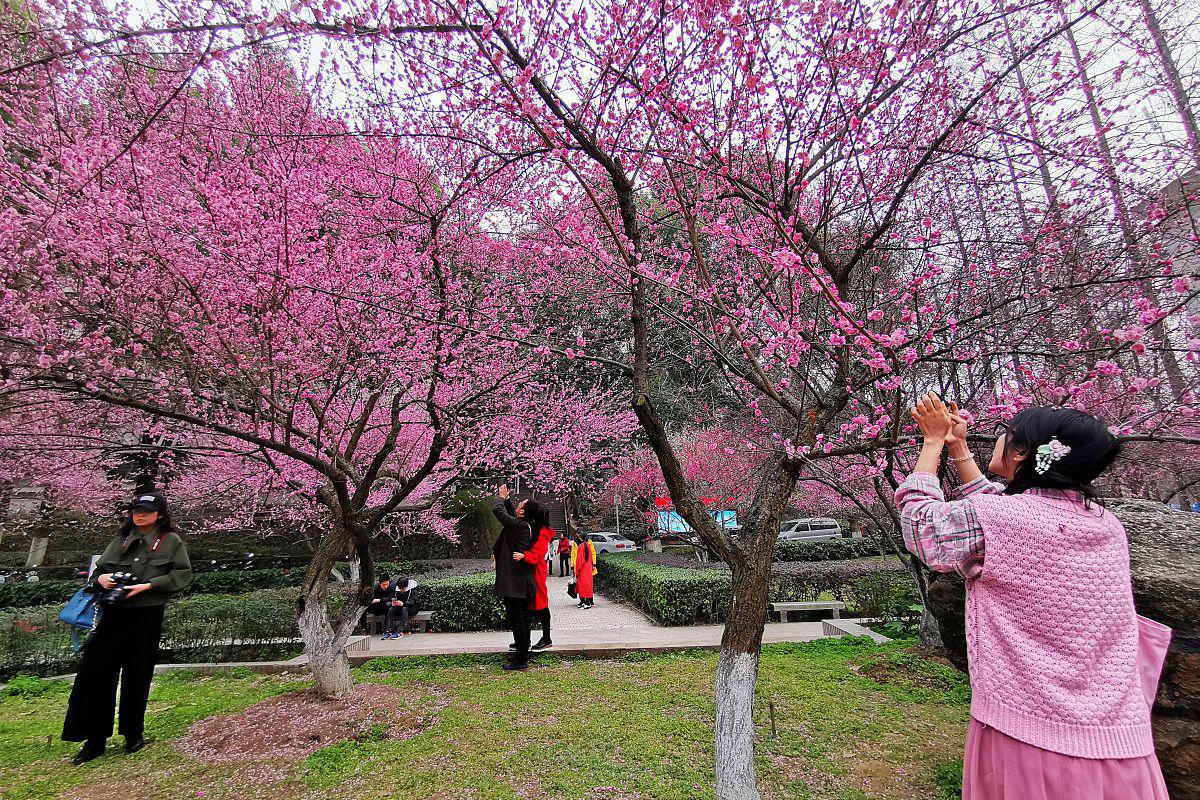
[715,563,770,800]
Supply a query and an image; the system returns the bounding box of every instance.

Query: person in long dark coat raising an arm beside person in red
[492,486,540,669]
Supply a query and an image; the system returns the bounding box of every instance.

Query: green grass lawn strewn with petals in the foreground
[0,639,967,800]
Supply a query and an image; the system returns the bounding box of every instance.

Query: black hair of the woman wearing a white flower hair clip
[1004,407,1121,500]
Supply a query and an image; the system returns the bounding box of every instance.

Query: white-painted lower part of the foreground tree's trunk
[716,648,760,800]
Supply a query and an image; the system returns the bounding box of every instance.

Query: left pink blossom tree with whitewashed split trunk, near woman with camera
[0,42,629,694]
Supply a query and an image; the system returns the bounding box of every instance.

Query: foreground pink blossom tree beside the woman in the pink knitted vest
[0,0,1200,799]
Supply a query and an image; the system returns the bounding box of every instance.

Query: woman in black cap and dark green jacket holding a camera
[62,492,192,765]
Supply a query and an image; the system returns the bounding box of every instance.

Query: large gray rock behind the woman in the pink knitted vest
[929,500,1200,799]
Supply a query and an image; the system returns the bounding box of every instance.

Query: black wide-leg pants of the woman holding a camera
[62,606,166,741]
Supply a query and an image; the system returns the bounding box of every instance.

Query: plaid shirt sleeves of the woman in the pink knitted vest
[896,473,1003,578]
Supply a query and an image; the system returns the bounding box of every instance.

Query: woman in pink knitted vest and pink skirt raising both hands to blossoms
[896,393,1170,800]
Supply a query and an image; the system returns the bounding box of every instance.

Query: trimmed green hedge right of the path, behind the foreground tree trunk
[598,554,917,625]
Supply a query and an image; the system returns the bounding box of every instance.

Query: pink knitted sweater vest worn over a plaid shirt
[966,493,1154,758]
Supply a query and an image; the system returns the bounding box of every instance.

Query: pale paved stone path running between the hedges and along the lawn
[343,577,824,663]
